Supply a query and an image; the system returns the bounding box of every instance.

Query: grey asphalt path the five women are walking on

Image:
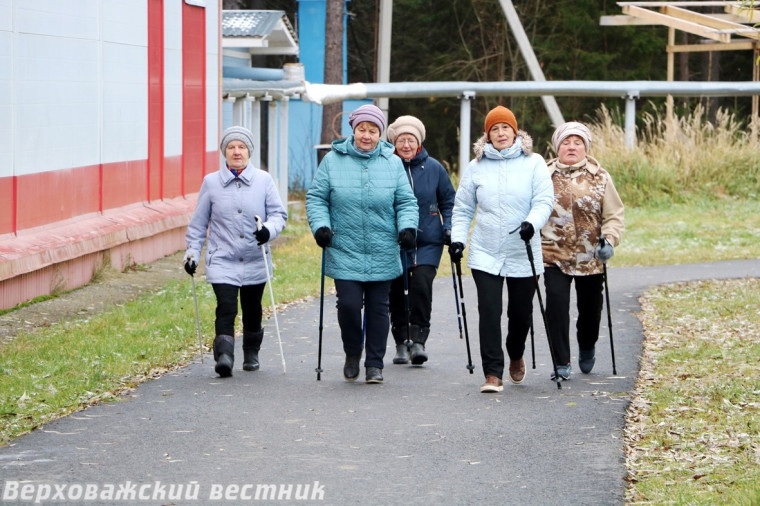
[0,260,760,505]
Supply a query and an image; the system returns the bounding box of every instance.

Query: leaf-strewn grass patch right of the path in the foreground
[626,279,760,504]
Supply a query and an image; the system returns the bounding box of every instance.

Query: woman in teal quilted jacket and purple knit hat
[306,104,418,383]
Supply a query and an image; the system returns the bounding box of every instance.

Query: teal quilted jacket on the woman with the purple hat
[306,135,419,281]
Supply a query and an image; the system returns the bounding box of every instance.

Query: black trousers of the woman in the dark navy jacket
[390,265,438,328]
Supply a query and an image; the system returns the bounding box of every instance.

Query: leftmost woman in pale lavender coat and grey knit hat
[185,126,288,378]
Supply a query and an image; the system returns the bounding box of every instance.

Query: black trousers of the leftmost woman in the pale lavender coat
[211,283,266,337]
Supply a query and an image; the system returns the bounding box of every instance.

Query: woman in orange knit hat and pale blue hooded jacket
[449,106,554,392]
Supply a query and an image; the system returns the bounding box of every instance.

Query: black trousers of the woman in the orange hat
[472,269,536,378]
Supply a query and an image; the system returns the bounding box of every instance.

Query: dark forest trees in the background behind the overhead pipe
[224,0,754,170]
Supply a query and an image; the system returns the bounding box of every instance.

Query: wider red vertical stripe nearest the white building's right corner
[182,3,206,195]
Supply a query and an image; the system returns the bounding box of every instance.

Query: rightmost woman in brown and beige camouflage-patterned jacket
[541,121,625,379]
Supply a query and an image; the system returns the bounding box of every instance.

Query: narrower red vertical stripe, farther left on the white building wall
[145,0,164,202]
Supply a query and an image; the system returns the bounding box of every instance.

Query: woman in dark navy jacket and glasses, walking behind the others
[388,116,455,365]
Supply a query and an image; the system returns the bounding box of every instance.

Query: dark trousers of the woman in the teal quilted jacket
[335,279,391,369]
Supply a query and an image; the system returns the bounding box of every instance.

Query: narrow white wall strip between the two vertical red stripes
[164,1,182,156]
